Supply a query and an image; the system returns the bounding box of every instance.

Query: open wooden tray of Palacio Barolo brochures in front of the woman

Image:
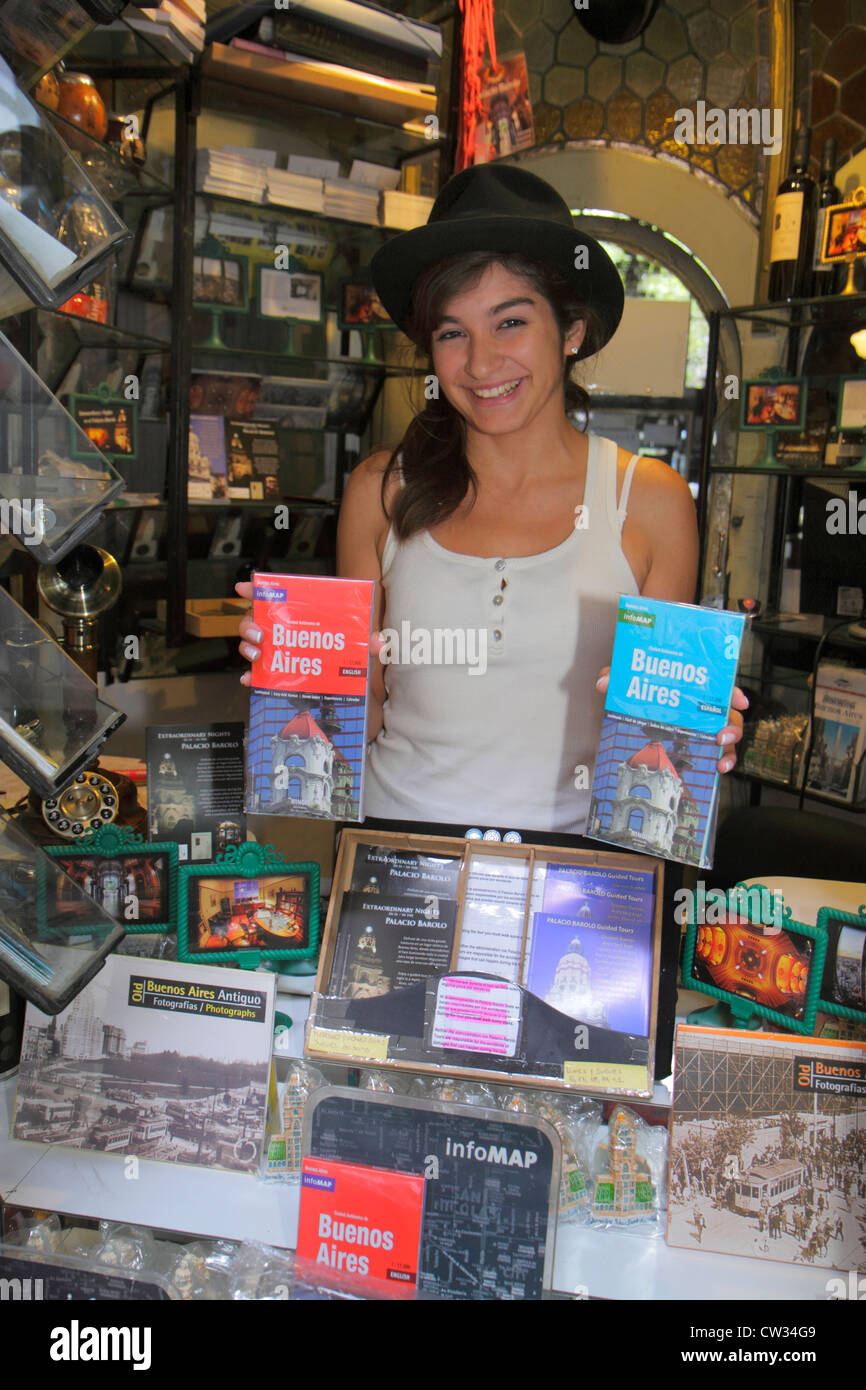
[306,830,663,1097]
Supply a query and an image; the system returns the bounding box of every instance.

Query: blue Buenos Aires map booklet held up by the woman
[587,596,745,869]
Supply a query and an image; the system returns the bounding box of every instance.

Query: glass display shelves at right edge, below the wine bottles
[699,295,866,810]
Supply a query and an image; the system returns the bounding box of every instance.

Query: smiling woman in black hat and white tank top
[239,165,745,834]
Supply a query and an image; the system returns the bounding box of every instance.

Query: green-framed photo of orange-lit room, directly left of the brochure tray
[178,842,318,969]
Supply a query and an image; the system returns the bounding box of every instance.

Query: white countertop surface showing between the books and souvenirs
[0,878,866,1301]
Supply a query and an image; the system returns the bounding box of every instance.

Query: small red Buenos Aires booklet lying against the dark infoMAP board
[297,1158,424,1291]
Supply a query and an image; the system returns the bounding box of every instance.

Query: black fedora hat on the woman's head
[370,164,624,357]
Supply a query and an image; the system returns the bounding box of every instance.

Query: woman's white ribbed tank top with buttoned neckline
[366,435,639,834]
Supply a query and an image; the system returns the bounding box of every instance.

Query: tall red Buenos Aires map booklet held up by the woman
[246,574,374,820]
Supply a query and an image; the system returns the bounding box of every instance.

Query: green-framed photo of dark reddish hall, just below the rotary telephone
[46,826,178,933]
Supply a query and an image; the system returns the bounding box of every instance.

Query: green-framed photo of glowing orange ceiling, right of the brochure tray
[683,884,827,1033]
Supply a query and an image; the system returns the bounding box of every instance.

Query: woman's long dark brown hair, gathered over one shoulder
[382,252,602,541]
